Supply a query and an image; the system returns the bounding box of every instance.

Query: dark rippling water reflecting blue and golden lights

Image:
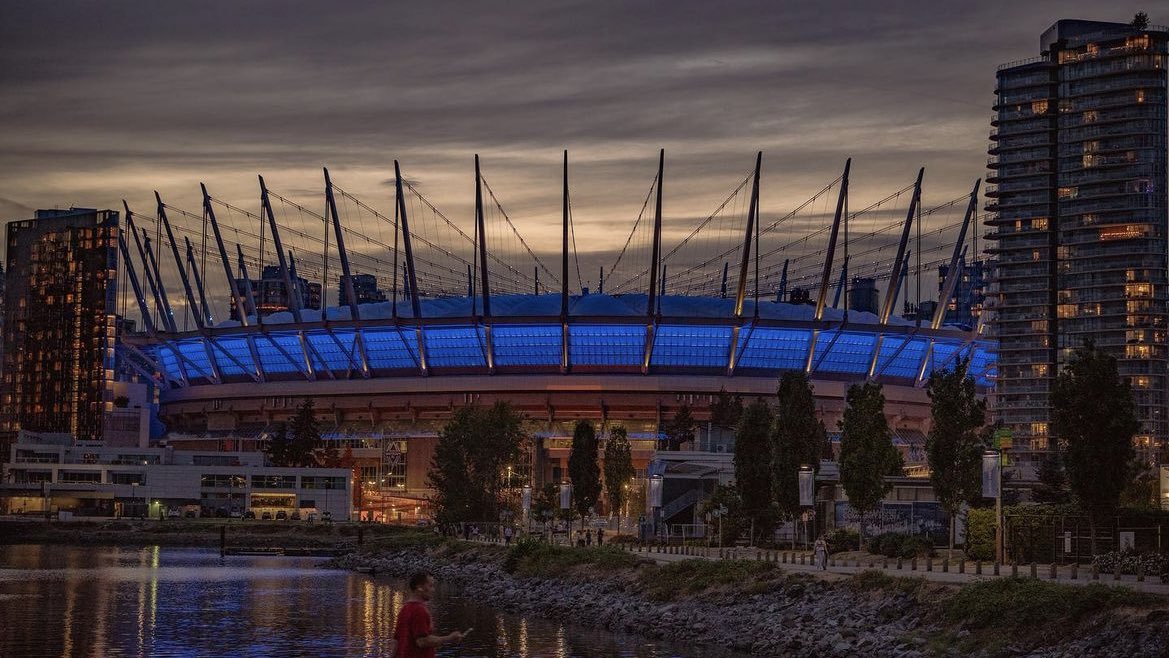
[0,546,733,658]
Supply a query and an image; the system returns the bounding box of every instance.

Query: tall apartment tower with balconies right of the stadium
[987,20,1169,460]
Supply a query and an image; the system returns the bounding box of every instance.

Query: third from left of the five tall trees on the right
[841,382,901,541]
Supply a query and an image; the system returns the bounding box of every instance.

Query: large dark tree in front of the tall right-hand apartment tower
[1051,340,1140,555]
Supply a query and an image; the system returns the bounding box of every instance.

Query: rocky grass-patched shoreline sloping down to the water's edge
[328,547,1169,658]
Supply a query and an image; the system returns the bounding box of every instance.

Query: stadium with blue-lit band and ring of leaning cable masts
[118,154,995,518]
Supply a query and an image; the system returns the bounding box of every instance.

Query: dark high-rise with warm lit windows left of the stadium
[0,208,118,448]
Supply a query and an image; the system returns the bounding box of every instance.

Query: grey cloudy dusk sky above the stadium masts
[0,0,1150,301]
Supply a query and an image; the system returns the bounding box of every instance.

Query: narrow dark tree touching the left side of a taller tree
[734,400,775,540]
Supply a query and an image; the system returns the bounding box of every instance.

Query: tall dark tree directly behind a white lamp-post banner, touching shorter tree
[772,370,828,528]
